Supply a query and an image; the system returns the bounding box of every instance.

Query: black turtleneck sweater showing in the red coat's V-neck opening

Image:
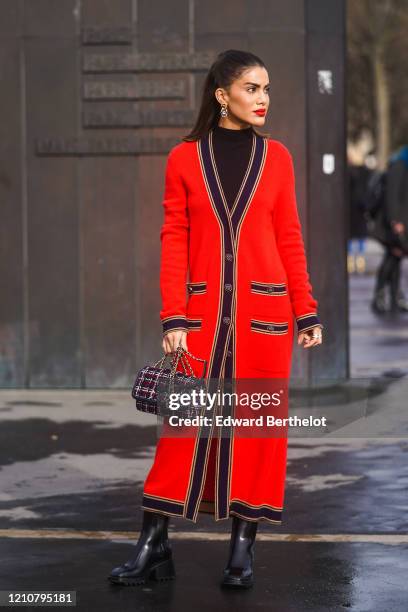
[213,125,254,210]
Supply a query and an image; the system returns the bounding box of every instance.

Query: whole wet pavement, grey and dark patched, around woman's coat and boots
[0,241,408,612]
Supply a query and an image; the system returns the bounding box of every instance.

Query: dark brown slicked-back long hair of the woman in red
[182,49,269,141]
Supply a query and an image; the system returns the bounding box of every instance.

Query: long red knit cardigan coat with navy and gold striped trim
[142,131,320,524]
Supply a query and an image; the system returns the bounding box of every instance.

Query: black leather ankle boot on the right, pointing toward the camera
[221,516,258,588]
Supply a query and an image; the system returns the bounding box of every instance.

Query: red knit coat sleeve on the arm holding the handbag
[160,149,189,335]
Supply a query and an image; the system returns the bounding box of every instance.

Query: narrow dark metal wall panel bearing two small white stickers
[306,0,350,380]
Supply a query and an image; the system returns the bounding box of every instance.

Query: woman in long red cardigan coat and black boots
[110,50,322,587]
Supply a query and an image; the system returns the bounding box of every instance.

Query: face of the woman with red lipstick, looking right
[215,66,269,128]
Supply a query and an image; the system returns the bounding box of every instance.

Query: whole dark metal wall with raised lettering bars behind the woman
[0,0,347,388]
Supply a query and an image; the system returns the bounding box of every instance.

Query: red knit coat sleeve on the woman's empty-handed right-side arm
[273,147,323,332]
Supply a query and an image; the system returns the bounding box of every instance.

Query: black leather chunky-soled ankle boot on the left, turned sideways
[108,510,176,586]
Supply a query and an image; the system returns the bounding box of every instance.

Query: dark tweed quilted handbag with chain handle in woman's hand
[132,346,207,417]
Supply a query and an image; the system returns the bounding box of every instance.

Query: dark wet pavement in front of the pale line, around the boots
[0,538,408,612]
